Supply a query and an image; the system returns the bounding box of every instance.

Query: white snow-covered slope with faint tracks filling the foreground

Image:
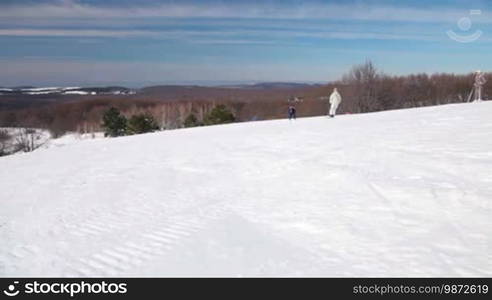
[0,102,492,276]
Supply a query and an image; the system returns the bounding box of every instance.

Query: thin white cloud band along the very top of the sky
[0,1,492,22]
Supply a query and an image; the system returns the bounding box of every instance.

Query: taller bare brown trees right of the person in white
[333,61,484,113]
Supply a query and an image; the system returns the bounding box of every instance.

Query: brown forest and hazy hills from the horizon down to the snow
[0,61,492,137]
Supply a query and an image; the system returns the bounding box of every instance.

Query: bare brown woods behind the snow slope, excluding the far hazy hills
[0,61,492,137]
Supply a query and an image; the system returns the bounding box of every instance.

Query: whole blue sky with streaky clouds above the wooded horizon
[0,0,492,86]
